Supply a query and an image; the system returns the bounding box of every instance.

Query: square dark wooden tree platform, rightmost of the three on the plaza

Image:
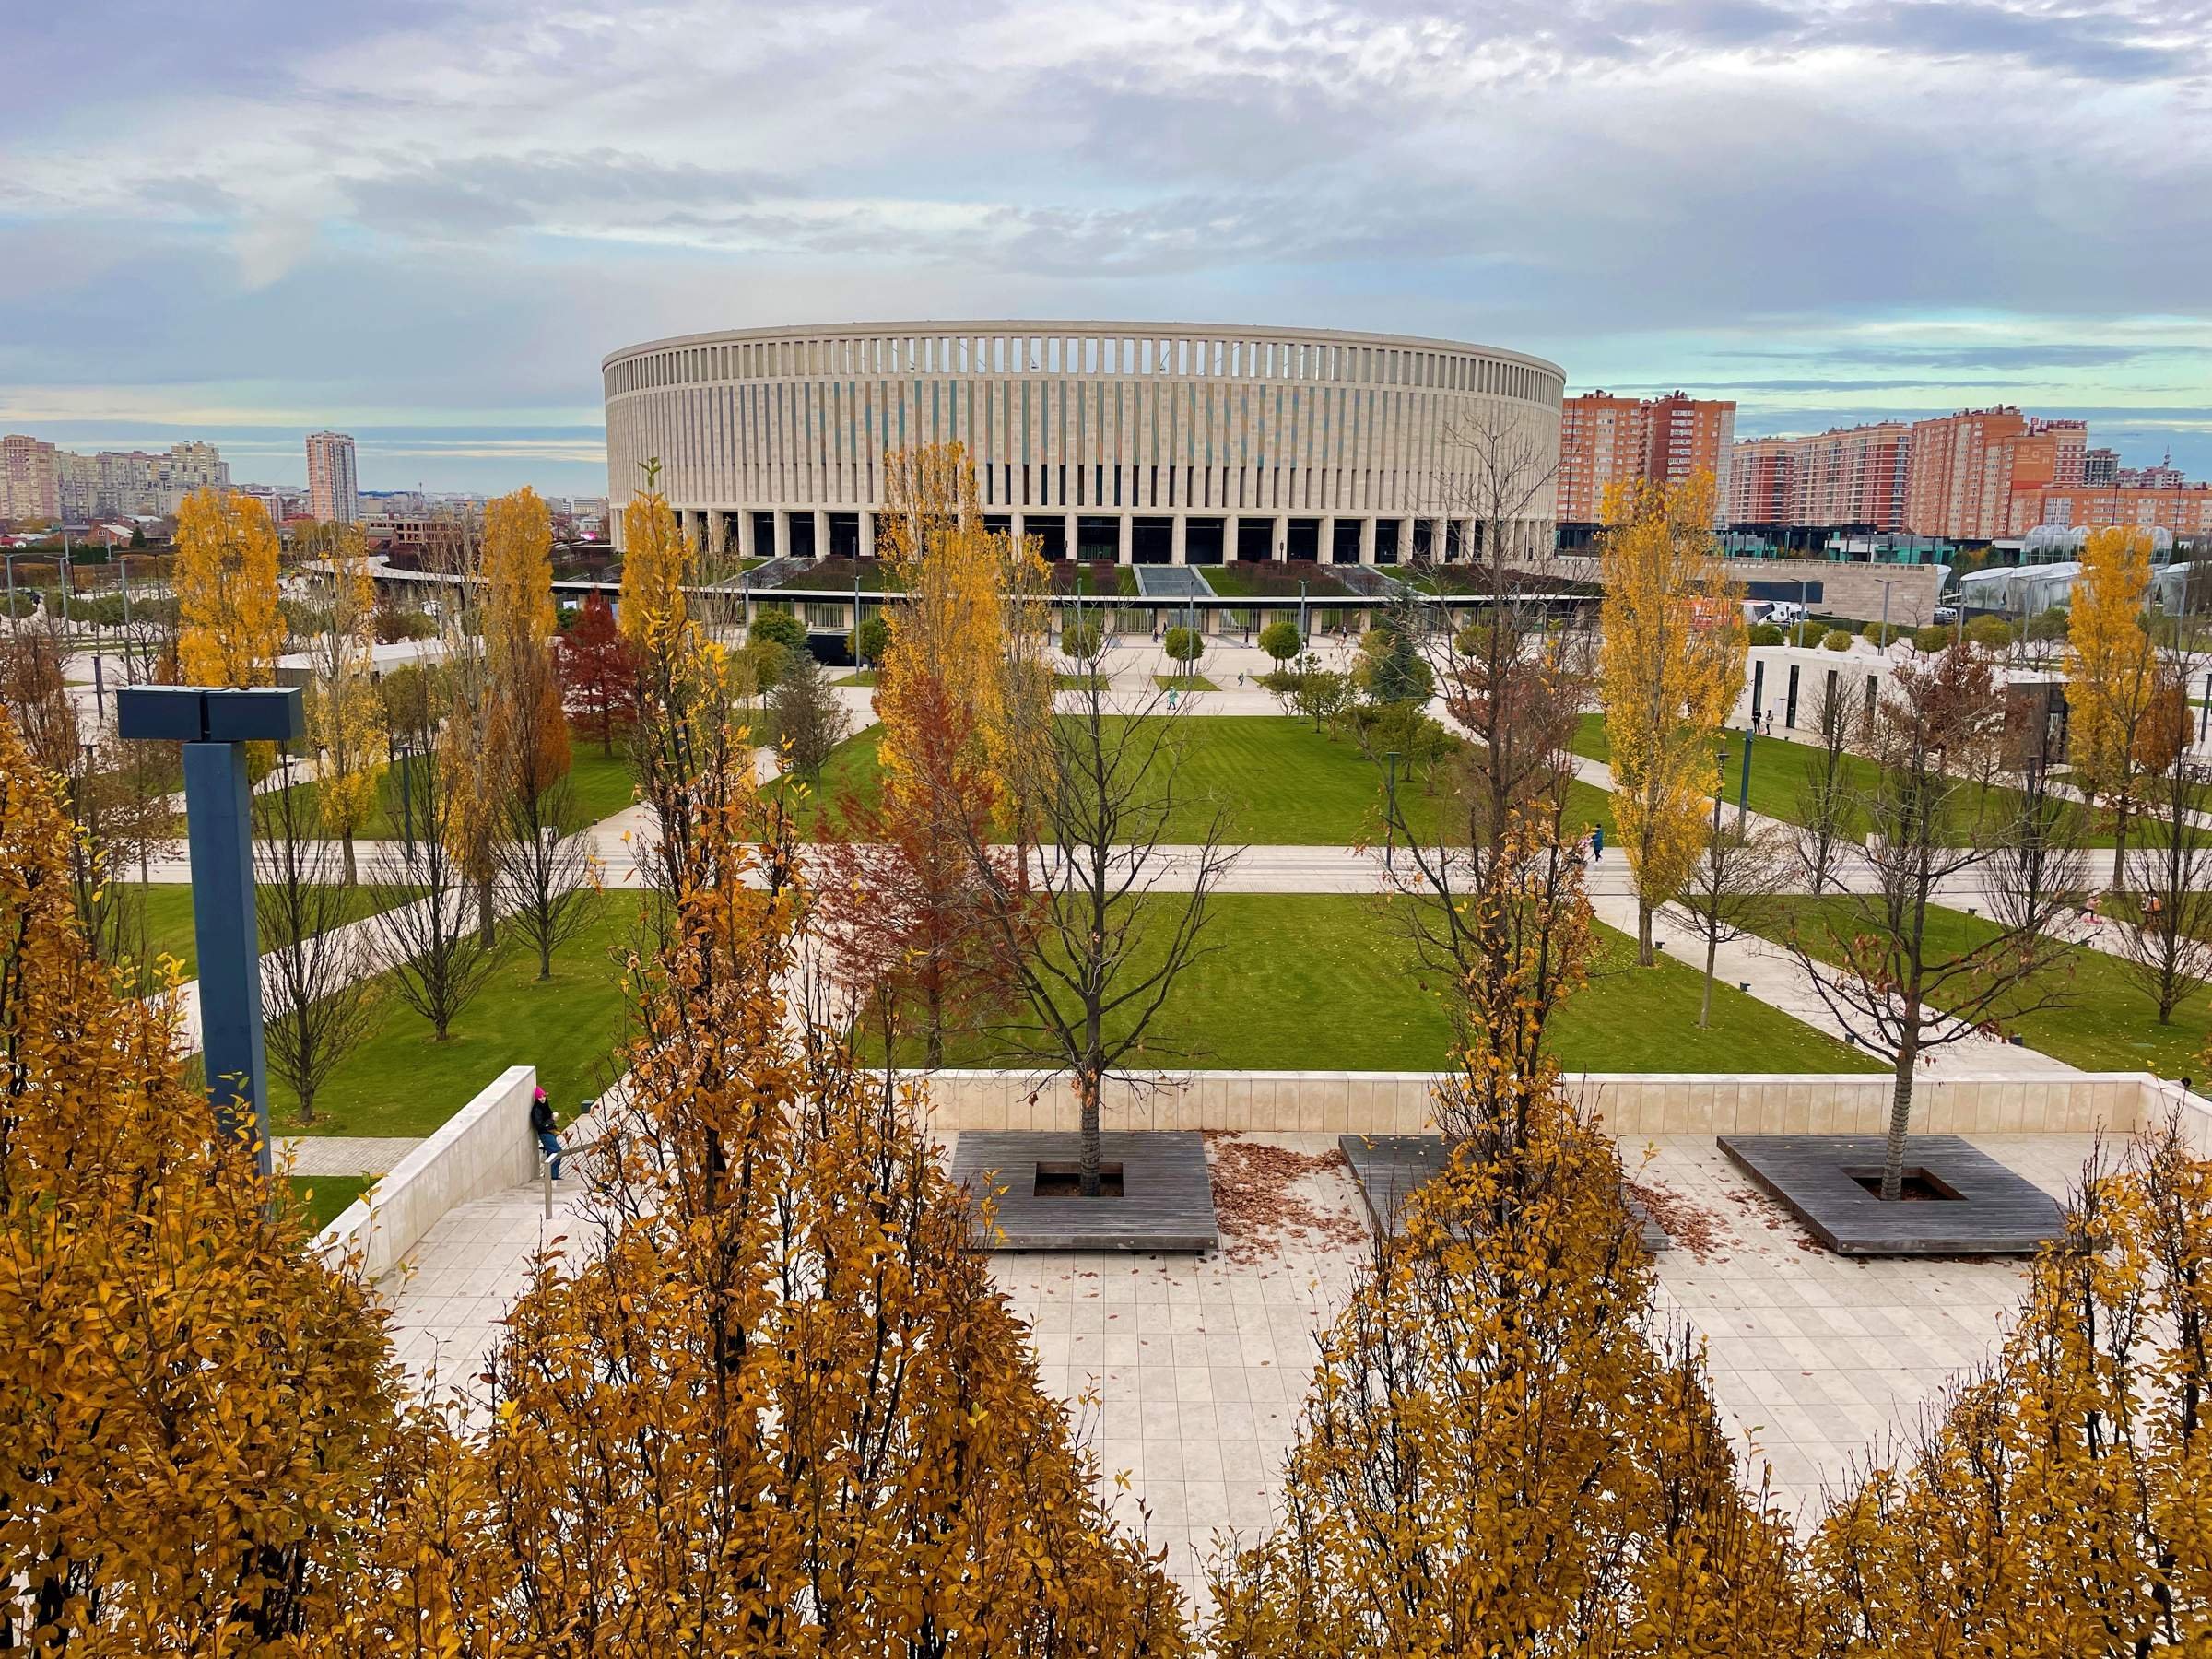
[1719,1135,2062,1256]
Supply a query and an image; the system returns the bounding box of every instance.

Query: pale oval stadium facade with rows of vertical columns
[602,323,1564,564]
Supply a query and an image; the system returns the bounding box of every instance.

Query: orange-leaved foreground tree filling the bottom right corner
[1807,1122,2212,1659]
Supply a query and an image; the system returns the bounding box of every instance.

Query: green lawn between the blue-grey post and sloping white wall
[270,894,640,1135]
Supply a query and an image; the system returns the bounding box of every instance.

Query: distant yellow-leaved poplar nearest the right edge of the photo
[2066,524,2170,887]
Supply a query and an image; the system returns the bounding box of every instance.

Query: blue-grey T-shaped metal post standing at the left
[115,686,308,1177]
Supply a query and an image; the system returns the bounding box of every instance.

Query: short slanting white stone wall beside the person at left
[316,1066,537,1283]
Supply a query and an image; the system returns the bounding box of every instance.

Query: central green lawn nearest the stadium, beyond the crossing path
[801,714,1615,845]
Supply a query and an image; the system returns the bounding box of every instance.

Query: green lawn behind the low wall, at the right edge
[1760,898,2212,1077]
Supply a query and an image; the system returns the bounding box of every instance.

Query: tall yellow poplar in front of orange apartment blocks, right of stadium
[1597,474,1749,967]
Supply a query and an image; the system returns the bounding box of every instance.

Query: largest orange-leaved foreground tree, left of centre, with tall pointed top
[474,787,1190,1659]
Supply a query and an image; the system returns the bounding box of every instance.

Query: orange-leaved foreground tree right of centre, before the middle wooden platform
[1212,986,1812,1659]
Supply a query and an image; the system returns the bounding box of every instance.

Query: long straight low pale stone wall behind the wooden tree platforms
[907,1071,2212,1150]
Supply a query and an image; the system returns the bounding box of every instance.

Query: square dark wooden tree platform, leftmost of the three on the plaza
[951,1128,1221,1252]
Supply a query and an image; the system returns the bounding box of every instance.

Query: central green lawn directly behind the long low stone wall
[907,894,1878,1071]
